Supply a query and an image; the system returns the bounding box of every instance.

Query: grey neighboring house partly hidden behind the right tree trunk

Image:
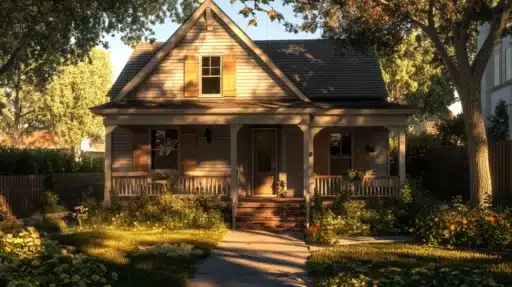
[477,24,512,136]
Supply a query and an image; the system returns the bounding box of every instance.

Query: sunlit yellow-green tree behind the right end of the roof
[379,31,456,122]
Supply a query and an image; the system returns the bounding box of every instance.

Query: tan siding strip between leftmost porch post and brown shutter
[112,127,133,171]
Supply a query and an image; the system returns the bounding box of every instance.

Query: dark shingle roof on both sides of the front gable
[109,39,387,101]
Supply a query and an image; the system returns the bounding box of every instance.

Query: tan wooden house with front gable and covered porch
[92,1,414,230]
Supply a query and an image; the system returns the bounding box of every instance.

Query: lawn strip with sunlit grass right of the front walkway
[308,243,512,286]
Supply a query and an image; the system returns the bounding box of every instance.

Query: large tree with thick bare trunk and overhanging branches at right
[232,0,512,205]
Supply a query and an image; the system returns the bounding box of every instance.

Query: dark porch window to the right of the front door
[329,133,352,175]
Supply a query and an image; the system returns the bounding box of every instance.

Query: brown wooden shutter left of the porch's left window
[132,127,151,171]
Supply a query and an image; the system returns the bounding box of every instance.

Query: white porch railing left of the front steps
[112,176,231,197]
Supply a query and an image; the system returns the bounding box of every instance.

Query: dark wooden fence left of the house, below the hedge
[0,173,103,216]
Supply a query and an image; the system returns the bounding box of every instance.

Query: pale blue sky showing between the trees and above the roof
[102,0,461,114]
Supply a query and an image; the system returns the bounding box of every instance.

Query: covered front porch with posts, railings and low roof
[101,102,412,228]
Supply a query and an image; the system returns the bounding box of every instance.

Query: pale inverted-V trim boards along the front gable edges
[112,0,311,102]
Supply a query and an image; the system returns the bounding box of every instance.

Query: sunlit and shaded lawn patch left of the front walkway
[52,230,226,287]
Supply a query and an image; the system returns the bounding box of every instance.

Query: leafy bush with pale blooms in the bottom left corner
[0,228,117,287]
